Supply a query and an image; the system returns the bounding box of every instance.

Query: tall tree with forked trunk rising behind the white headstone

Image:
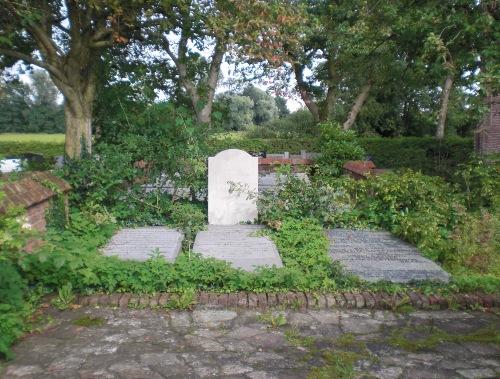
[139,0,296,123]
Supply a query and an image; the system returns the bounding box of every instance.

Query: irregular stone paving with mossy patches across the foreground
[0,308,500,379]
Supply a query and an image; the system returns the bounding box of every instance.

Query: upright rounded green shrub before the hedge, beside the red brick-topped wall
[317,122,365,177]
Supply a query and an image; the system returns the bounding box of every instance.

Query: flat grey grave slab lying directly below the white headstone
[193,225,283,271]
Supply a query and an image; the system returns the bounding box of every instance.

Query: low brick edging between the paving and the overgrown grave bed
[76,291,500,310]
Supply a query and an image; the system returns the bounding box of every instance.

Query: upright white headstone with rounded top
[208,149,259,225]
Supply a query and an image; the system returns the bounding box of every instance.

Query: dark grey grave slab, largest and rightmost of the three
[327,229,449,283]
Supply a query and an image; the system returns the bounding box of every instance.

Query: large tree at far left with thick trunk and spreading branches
[0,0,143,158]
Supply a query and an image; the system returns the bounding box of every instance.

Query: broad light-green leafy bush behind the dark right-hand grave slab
[345,171,463,261]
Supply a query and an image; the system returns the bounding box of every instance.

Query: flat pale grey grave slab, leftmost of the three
[103,226,184,262]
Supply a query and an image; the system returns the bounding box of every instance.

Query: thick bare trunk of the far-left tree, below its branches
[64,99,92,159]
